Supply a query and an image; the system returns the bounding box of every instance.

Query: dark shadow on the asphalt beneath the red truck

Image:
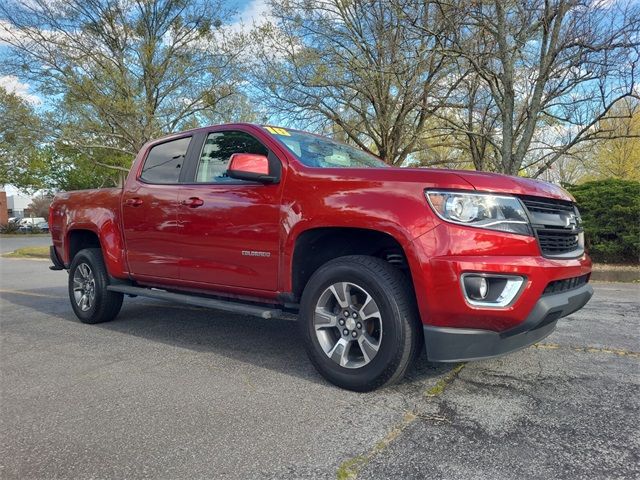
[0,287,454,390]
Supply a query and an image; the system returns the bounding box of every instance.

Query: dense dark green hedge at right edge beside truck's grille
[568,179,640,263]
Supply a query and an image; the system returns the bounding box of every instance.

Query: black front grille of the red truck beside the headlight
[521,197,584,257]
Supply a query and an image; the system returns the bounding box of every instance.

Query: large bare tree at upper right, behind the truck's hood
[432,0,640,177]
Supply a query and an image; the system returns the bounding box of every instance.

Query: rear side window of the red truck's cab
[140,137,191,183]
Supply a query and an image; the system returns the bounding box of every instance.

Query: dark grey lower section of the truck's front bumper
[423,284,593,362]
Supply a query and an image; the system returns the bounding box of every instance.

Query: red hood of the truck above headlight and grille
[455,170,575,202]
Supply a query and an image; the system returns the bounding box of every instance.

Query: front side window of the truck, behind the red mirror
[196,132,269,183]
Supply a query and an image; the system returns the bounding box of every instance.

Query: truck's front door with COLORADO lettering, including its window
[178,128,282,291]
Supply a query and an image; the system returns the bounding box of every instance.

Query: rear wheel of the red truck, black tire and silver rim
[69,248,124,324]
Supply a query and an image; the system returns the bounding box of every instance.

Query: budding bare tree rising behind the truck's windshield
[253,0,458,165]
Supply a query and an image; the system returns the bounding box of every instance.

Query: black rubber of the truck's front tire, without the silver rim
[299,260,407,391]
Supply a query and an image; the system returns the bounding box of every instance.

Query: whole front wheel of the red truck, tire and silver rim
[298,255,422,392]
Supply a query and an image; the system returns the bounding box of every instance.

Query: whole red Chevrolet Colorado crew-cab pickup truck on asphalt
[49,124,593,391]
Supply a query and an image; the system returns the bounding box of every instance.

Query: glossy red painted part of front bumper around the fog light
[408,225,591,332]
